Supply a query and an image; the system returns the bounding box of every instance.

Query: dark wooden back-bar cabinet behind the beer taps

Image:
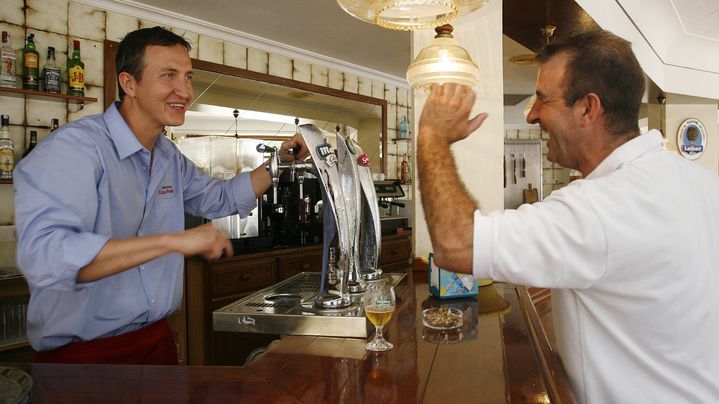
[185,234,412,365]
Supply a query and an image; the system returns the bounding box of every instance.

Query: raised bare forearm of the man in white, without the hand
[417,135,477,273]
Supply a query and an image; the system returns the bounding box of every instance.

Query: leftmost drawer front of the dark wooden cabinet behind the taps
[211,257,277,298]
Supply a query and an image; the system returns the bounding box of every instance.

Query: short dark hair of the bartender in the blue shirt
[115,27,192,100]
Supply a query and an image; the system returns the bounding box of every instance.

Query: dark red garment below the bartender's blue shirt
[34,320,178,365]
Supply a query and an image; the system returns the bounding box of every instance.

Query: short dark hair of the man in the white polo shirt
[536,30,645,135]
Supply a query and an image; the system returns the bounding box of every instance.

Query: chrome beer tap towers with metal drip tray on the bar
[213,124,405,338]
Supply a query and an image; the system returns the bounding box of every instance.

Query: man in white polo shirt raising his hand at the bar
[418,31,719,404]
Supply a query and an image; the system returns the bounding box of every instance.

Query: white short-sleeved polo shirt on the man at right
[473,130,719,404]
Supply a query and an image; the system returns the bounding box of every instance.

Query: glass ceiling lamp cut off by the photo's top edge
[337,0,487,31]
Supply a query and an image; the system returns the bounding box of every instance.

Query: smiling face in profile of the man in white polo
[527,53,579,168]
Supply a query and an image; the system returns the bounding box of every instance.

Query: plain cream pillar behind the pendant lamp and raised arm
[412,0,504,257]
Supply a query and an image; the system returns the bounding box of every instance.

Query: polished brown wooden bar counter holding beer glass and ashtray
[5,276,574,403]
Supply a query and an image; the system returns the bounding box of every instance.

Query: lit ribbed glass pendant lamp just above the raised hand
[407,24,479,92]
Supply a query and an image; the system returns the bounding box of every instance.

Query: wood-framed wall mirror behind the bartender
[104,41,387,177]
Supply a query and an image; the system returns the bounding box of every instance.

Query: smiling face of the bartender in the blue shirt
[121,45,192,133]
